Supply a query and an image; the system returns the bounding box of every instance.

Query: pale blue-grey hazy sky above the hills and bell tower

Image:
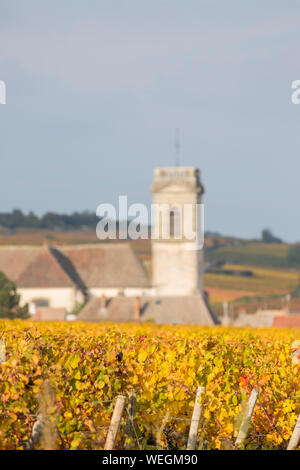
[0,0,300,241]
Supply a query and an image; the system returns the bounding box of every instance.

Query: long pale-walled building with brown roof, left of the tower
[0,243,152,313]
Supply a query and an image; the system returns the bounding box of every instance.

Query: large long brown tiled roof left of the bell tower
[0,243,150,294]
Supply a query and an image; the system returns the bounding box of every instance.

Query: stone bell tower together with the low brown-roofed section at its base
[79,167,220,325]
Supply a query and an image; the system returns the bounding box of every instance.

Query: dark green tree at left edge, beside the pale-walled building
[0,271,29,320]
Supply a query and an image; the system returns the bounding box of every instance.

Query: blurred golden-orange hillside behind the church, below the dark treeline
[0,224,300,311]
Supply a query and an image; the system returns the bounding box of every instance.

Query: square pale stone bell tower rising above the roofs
[152,167,204,296]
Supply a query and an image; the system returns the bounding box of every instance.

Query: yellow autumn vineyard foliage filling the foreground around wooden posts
[0,321,300,449]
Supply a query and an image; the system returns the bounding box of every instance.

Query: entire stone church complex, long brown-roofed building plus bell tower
[0,167,219,325]
